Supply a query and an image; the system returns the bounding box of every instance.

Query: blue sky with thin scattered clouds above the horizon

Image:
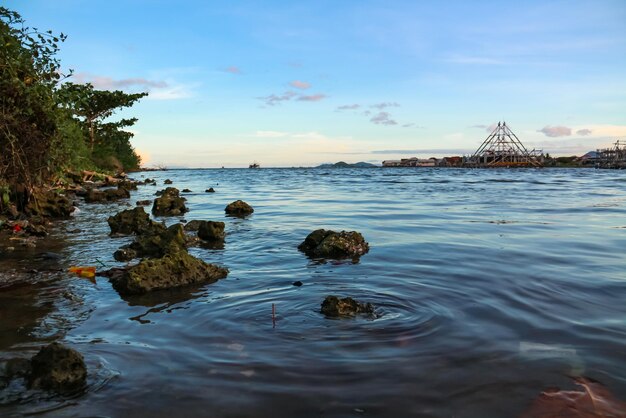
[3,0,626,167]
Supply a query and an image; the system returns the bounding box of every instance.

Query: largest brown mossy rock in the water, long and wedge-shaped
[110,251,228,295]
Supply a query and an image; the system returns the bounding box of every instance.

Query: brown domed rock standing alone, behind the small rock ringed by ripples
[298,229,369,258]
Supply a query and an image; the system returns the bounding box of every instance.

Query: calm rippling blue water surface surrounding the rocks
[0,169,626,417]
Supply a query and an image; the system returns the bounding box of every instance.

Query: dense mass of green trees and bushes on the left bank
[0,7,147,196]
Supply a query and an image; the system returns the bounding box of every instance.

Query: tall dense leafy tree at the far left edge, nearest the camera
[0,7,66,189]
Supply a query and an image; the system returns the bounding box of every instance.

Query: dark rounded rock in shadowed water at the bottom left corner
[28,342,87,393]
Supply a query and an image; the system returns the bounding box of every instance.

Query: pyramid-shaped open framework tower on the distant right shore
[464,122,543,168]
